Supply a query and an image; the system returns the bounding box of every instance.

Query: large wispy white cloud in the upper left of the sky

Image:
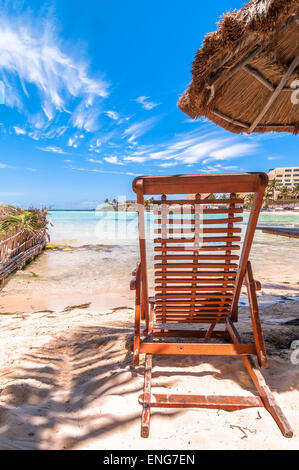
[0,12,108,130]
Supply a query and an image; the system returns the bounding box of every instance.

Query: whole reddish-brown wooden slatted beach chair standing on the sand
[131,173,293,437]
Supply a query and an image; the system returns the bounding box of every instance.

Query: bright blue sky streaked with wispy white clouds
[0,0,298,209]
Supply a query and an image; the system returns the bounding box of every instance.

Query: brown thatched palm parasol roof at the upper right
[178,0,299,134]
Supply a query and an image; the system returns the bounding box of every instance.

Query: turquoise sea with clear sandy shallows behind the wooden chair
[0,211,299,315]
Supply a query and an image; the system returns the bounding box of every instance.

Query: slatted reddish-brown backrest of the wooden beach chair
[133,173,268,323]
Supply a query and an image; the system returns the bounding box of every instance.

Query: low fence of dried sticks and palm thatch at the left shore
[0,205,49,282]
